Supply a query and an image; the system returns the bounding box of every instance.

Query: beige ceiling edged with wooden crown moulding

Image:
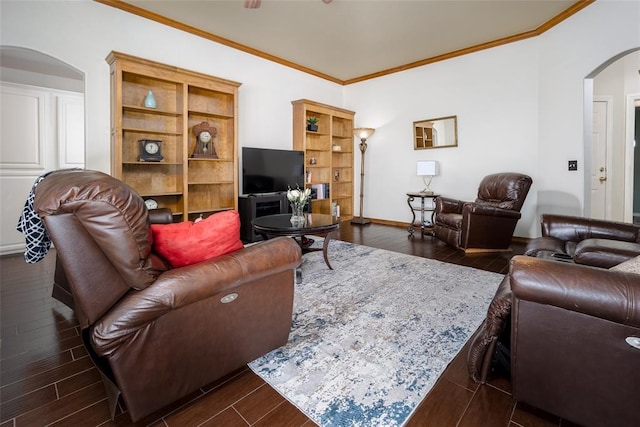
[115,0,593,83]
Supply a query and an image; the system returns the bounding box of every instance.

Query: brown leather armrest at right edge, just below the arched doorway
[540,214,640,243]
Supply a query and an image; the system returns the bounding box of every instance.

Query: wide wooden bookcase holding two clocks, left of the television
[107,52,240,221]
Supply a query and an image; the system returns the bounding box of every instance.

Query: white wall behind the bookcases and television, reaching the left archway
[0,0,343,172]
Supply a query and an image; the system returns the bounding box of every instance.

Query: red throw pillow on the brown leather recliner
[151,211,243,268]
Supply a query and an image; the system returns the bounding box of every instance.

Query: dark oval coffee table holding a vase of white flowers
[251,214,340,270]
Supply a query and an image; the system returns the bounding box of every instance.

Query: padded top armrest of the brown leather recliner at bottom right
[509,256,640,327]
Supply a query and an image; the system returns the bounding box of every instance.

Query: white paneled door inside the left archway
[0,83,84,254]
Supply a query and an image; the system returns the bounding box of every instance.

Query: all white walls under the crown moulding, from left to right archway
[0,0,640,237]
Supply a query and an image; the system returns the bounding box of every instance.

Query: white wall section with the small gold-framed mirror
[345,40,538,235]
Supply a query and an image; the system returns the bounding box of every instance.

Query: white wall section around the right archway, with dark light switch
[538,0,640,227]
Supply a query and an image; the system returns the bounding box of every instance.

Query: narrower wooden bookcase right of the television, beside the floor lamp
[292,99,355,220]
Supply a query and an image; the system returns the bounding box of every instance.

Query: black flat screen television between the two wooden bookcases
[242,147,304,195]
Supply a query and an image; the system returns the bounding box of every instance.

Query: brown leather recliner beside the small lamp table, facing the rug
[433,173,532,252]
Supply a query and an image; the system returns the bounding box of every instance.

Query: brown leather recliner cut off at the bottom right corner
[467,256,640,427]
